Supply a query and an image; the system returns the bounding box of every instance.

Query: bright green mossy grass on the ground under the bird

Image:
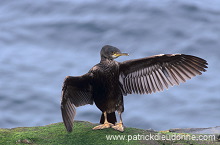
[0,121,218,145]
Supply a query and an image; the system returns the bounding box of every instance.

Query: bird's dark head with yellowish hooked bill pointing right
[100,45,129,60]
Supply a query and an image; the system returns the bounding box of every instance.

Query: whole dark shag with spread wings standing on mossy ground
[61,45,208,132]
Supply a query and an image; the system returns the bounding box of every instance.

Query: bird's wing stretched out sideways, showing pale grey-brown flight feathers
[119,54,208,95]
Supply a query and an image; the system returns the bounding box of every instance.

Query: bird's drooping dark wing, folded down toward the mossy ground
[61,73,93,132]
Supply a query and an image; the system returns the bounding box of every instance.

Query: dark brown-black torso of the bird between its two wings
[90,61,122,112]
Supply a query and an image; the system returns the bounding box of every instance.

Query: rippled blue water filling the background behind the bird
[0,0,220,130]
